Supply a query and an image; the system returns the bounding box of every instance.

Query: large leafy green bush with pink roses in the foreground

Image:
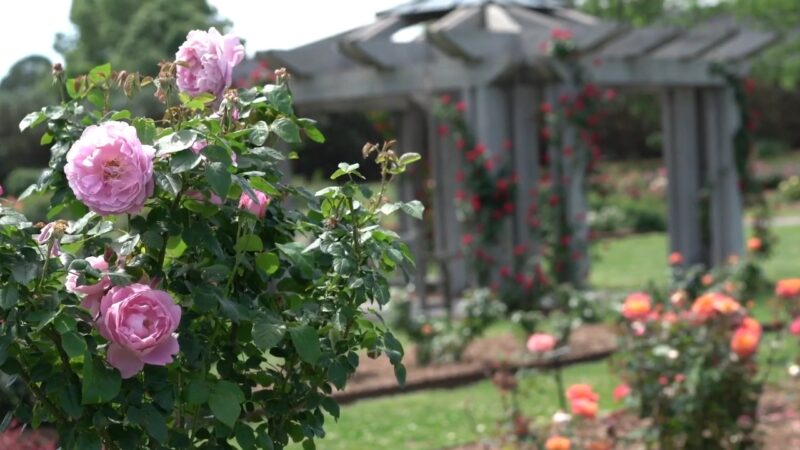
[0,29,422,450]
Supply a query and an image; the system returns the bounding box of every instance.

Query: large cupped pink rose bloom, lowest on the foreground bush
[97,284,181,378]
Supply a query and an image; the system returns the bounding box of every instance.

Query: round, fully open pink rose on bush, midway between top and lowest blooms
[64,121,155,216]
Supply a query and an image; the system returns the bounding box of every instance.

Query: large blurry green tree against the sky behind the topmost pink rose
[55,0,229,75]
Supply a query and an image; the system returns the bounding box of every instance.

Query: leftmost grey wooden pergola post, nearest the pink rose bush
[397,103,431,310]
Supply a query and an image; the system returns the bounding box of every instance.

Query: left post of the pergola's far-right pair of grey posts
[661,88,706,264]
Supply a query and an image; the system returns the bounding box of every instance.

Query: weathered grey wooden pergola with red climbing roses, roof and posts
[256,0,778,298]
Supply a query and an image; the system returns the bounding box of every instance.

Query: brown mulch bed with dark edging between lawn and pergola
[334,325,616,403]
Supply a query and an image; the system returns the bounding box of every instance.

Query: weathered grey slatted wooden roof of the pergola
[257,0,778,109]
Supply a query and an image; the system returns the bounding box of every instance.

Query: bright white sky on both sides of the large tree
[0,0,404,78]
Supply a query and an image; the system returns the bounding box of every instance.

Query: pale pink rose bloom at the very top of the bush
[175,27,244,100]
